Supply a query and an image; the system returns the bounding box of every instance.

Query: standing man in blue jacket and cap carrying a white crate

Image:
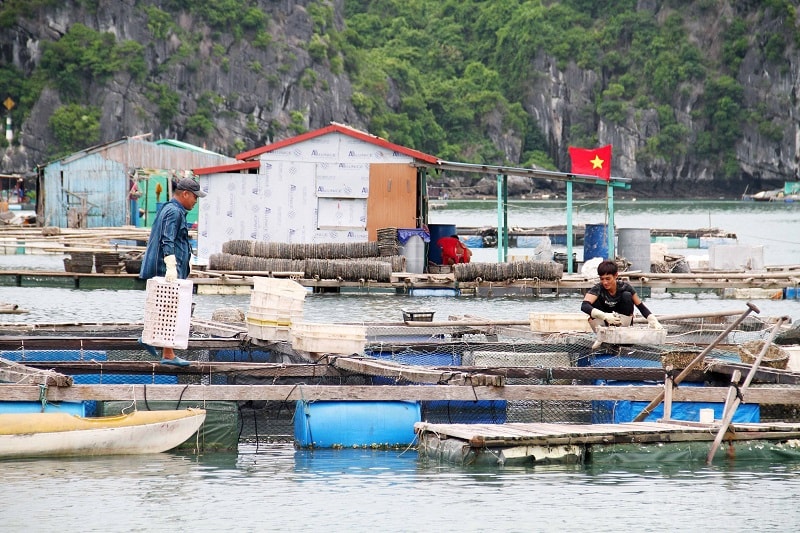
[139,178,206,366]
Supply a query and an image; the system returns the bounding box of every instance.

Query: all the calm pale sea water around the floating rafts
[0,201,800,531]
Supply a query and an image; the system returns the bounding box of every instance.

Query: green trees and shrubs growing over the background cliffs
[0,0,800,177]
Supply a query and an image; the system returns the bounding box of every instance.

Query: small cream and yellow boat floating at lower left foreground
[0,409,206,458]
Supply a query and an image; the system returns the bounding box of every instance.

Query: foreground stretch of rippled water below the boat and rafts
[0,445,800,531]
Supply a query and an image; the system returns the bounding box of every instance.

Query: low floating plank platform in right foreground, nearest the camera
[414,421,800,466]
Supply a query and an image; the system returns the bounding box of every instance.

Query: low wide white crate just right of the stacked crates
[291,322,367,355]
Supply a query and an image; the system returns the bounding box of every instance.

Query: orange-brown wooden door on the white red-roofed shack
[367,163,417,241]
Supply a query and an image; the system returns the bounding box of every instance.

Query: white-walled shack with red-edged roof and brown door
[194,123,437,258]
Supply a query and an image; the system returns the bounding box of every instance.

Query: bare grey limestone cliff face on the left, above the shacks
[0,0,364,172]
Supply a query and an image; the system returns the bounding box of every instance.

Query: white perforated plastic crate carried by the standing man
[142,277,193,350]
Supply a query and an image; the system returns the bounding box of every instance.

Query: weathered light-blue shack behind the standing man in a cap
[36,137,235,228]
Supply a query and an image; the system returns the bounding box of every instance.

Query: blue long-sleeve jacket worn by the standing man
[139,198,192,279]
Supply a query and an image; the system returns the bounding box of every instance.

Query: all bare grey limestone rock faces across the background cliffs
[0,0,800,200]
